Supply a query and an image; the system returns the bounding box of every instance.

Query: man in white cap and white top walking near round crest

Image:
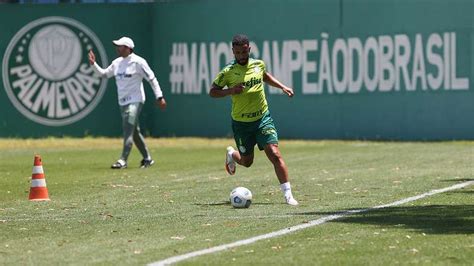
[89,37,166,169]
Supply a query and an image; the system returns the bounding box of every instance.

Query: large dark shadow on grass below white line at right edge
[292,205,474,234]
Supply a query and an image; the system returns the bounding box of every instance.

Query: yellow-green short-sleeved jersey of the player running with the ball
[214,58,268,122]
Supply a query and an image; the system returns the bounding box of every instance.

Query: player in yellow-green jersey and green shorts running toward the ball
[209,35,298,206]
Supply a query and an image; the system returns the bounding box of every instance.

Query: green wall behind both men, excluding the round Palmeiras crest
[0,0,474,140]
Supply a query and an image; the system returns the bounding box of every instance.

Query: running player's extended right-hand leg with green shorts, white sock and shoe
[257,114,298,206]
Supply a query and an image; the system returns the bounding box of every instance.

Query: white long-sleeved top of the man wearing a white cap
[93,53,163,106]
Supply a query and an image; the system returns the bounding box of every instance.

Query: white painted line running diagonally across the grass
[148,181,474,266]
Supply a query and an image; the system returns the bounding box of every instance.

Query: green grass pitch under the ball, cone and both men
[0,138,474,265]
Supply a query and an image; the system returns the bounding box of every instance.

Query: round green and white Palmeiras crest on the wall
[2,17,108,126]
